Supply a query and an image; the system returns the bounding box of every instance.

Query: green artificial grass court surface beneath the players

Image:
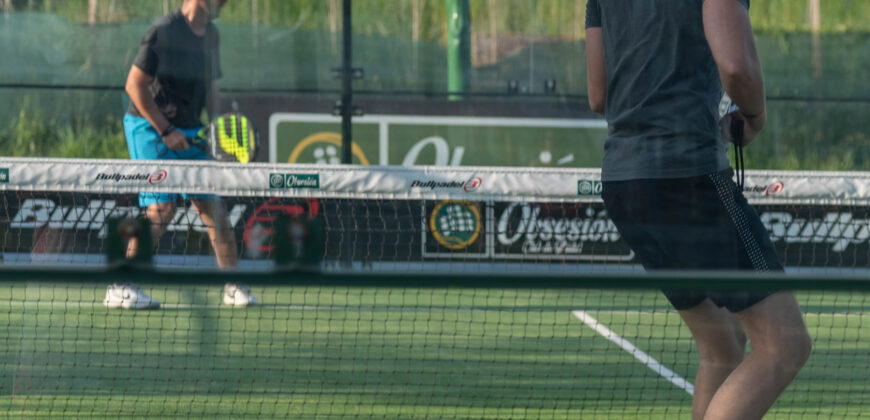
[0,282,870,419]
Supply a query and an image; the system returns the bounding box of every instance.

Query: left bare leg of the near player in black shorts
[679,299,746,420]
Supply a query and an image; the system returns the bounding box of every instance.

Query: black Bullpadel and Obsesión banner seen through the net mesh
[0,191,870,268]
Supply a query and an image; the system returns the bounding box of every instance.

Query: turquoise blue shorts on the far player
[124,114,220,207]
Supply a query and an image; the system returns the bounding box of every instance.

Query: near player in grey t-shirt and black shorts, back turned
[586,0,811,419]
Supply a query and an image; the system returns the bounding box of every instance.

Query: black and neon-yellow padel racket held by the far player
[191,112,260,163]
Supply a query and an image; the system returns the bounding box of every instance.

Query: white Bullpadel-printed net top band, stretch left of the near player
[0,158,597,199]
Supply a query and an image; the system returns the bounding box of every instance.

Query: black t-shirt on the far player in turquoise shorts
[127,10,221,128]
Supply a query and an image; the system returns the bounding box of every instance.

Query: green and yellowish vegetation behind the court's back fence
[0,0,870,170]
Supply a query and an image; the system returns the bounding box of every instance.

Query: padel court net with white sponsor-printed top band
[0,159,870,419]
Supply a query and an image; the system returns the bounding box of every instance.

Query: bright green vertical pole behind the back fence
[444,0,471,100]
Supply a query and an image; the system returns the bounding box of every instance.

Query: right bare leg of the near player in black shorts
[704,292,812,420]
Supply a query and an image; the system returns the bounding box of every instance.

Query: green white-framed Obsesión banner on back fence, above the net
[269,113,607,168]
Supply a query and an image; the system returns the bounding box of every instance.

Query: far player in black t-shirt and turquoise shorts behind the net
[103,0,256,309]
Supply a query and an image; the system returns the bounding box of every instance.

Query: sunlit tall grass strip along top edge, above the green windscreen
[11,0,870,36]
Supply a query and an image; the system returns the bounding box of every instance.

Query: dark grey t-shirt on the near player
[586,0,749,181]
